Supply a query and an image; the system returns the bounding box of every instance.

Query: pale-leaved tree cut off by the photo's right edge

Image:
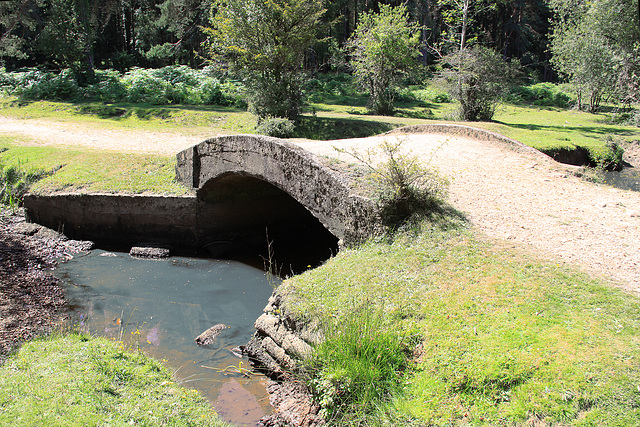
[551,0,640,112]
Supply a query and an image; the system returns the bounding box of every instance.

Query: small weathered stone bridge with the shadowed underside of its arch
[176,135,374,249]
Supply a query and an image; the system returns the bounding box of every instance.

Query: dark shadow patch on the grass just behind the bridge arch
[295,116,397,141]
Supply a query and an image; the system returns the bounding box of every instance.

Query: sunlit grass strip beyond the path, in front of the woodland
[0,86,640,160]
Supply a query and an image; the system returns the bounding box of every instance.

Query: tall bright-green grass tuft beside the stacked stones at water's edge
[307,303,409,425]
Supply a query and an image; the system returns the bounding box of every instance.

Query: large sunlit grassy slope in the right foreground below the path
[282,216,640,426]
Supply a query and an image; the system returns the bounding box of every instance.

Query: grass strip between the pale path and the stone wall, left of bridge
[0,136,189,195]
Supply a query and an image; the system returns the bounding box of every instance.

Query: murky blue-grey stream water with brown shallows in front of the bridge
[56,250,272,426]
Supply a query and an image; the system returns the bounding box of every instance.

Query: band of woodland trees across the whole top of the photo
[0,0,640,120]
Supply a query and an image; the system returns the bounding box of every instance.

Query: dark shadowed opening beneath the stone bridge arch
[197,172,338,276]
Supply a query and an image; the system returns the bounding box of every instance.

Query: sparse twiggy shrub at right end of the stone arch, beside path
[338,139,448,228]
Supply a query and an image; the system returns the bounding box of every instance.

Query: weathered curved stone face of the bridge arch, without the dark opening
[176,135,374,247]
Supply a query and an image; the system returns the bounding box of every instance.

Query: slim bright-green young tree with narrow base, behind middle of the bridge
[347,5,421,114]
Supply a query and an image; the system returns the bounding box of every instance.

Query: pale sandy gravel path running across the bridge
[0,118,640,292]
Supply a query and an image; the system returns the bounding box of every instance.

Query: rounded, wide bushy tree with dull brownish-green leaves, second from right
[441,46,517,121]
